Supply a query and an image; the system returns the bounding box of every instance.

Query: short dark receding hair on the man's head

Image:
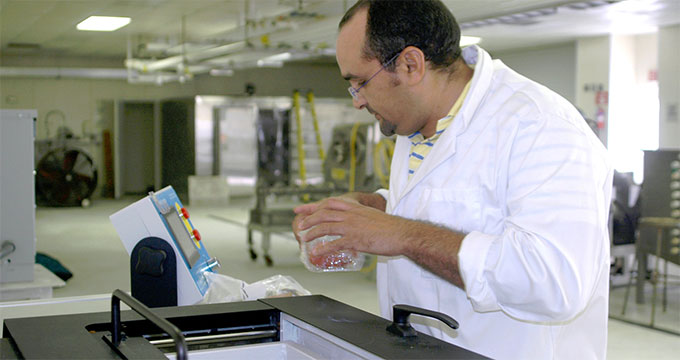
[339,0,461,71]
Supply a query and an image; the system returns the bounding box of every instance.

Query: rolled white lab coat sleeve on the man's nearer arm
[459,111,611,322]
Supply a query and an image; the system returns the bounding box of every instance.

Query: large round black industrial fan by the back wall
[36,148,97,206]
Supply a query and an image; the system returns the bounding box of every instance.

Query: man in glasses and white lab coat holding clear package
[293,0,612,359]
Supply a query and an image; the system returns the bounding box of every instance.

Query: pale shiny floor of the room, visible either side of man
[6,199,680,359]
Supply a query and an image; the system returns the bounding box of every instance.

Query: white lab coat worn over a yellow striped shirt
[378,46,613,359]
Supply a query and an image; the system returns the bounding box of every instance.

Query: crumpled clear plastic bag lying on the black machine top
[198,271,311,304]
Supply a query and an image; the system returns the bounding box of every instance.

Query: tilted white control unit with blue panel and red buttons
[110,186,219,307]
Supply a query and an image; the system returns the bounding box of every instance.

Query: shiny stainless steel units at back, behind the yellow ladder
[193,96,370,191]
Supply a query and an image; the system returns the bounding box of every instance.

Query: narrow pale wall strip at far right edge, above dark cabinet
[658,25,680,149]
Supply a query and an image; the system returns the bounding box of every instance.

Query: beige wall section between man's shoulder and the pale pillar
[492,42,576,103]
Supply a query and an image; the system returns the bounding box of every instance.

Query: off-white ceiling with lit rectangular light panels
[0,0,680,72]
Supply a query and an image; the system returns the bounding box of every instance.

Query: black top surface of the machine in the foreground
[0,295,484,359]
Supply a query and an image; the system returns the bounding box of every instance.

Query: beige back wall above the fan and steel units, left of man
[0,56,350,196]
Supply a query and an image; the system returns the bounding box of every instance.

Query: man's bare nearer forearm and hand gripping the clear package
[293,193,465,288]
